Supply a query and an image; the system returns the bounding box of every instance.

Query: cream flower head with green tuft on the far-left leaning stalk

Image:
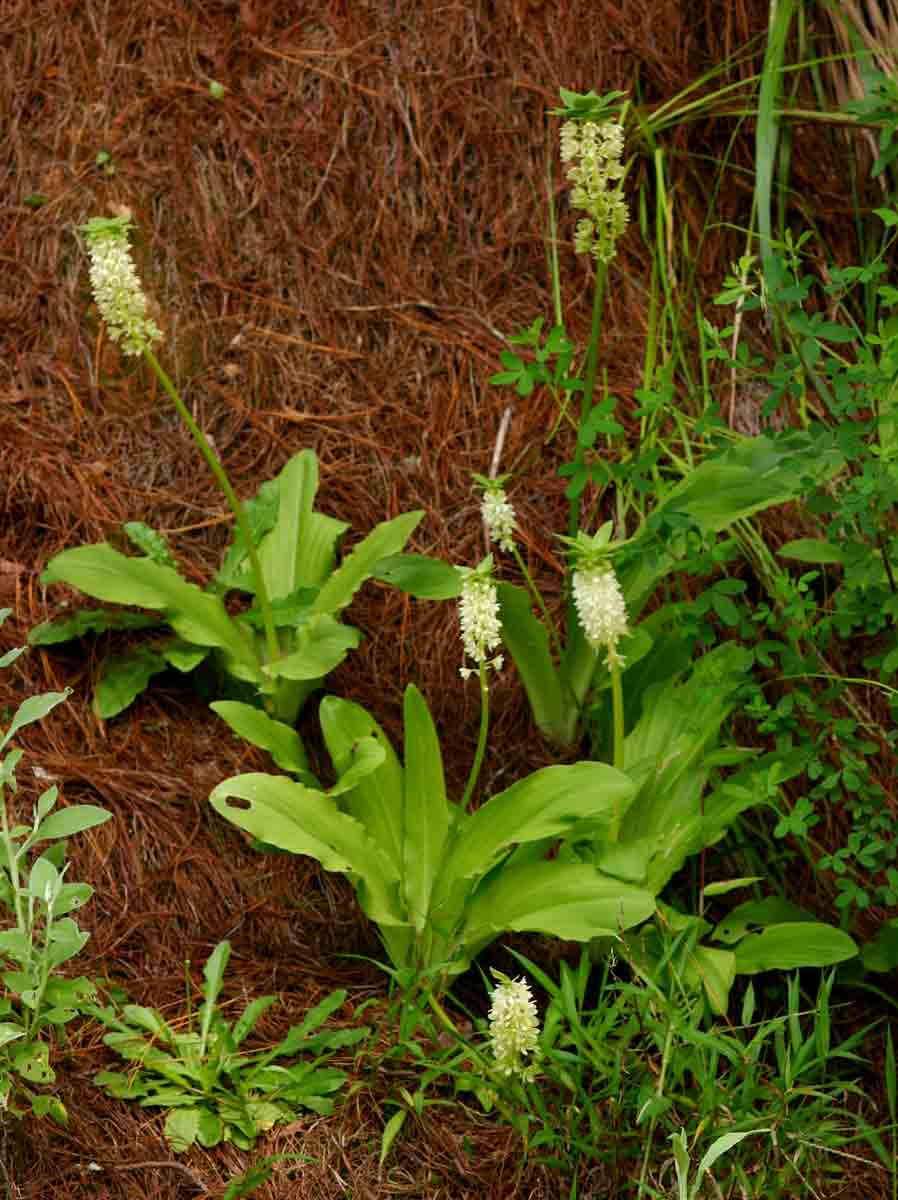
[85,217,162,354]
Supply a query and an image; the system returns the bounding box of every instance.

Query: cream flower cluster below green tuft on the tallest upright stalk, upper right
[561,121,629,263]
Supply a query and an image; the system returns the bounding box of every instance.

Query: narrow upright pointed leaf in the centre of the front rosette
[402,684,453,931]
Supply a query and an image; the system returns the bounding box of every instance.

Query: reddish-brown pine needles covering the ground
[0,0,893,1200]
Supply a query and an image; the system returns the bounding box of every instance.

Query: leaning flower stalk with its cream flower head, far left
[82,216,281,681]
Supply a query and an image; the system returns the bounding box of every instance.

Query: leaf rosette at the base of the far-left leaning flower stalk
[29,450,424,725]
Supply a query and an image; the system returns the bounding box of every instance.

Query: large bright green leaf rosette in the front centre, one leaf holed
[210,685,654,977]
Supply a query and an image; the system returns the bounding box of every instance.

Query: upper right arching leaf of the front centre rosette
[441,762,634,896]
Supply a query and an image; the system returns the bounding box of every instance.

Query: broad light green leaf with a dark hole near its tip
[209,774,405,925]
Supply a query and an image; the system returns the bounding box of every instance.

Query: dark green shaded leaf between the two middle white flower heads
[498,583,569,744]
